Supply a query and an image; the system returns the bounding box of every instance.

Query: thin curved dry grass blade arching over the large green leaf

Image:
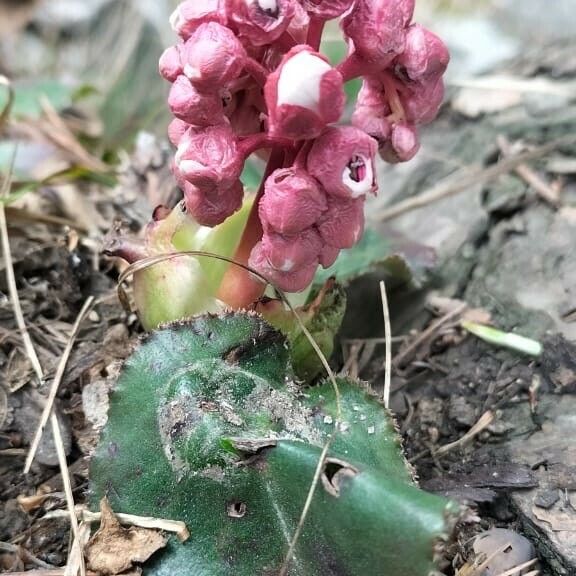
[118,250,342,576]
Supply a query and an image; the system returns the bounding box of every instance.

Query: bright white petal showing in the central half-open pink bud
[278,52,332,112]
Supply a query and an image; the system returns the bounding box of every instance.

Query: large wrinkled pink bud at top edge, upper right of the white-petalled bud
[342,0,415,69]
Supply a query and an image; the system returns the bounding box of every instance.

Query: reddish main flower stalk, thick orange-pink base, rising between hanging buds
[217,149,284,310]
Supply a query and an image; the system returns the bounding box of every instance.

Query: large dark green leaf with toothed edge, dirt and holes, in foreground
[90,314,459,576]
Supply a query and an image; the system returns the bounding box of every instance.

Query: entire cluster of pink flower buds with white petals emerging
[160,0,448,292]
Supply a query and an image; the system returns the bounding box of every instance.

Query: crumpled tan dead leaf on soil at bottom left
[86,498,167,576]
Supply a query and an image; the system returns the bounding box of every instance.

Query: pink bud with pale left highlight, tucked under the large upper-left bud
[168,76,226,126]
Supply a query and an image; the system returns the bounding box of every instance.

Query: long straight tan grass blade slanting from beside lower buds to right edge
[376,134,576,222]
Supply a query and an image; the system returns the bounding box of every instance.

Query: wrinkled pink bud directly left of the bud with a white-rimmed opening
[258,168,327,235]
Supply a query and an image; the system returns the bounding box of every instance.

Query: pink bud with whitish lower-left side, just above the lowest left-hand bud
[174,125,244,193]
